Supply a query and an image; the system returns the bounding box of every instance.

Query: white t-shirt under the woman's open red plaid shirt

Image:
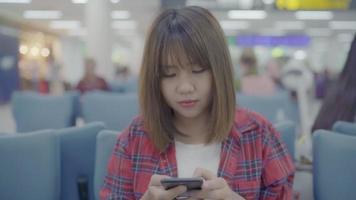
[175,141,221,178]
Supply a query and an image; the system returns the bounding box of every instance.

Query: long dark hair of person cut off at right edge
[312,35,356,131]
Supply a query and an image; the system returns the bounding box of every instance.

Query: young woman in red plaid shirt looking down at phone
[100,7,294,200]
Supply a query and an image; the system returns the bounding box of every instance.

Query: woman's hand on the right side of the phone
[190,168,244,200]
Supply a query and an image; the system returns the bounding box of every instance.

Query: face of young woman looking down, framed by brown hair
[161,56,212,120]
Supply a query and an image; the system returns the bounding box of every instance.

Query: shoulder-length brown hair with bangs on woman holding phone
[139,6,235,150]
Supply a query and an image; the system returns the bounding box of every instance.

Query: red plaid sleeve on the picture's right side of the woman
[260,125,295,200]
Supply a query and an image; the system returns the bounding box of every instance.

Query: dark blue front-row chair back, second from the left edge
[57,122,104,200]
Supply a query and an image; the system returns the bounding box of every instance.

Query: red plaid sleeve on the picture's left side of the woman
[100,130,134,200]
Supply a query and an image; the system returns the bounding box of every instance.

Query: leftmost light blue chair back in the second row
[11,92,75,132]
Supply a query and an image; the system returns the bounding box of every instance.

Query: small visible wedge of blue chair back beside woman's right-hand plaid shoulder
[274,121,296,159]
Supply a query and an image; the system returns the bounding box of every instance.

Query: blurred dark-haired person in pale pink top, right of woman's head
[240,49,276,95]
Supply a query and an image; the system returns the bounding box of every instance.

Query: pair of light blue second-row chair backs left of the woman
[11,91,139,132]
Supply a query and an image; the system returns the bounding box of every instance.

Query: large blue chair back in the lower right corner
[313,130,356,200]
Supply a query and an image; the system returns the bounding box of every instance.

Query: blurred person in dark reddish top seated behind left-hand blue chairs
[76,58,109,93]
